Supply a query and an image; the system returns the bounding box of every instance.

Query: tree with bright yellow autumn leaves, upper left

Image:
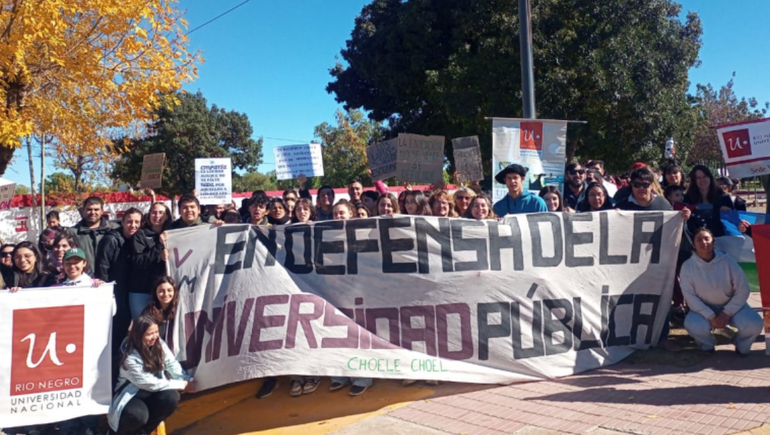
[0,0,200,175]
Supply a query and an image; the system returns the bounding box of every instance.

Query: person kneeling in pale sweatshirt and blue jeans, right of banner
[679,228,763,355]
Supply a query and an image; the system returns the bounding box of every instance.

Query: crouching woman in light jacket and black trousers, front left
[108,314,193,434]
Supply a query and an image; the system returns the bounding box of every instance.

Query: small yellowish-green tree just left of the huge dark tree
[315,109,382,187]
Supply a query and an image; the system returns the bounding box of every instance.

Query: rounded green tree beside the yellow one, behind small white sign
[112,92,262,195]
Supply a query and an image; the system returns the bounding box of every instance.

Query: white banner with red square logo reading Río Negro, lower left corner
[0,284,112,428]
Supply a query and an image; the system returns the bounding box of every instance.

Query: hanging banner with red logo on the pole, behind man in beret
[492,118,567,201]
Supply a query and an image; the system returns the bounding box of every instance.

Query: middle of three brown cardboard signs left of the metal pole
[396,133,444,183]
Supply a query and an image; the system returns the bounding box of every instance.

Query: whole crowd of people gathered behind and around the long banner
[0,160,763,434]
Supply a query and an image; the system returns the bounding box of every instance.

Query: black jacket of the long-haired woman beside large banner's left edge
[128,228,166,293]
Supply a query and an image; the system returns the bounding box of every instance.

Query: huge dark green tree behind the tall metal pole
[327,0,702,174]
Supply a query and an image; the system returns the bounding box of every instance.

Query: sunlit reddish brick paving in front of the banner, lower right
[388,295,770,435]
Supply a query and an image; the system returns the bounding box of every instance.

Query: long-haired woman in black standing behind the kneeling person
[684,165,734,237]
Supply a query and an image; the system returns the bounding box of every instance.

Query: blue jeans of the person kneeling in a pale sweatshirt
[684,304,764,354]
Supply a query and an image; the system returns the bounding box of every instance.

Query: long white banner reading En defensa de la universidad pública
[169,211,682,389]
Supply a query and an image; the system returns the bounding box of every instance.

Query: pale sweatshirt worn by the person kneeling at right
[679,251,750,319]
